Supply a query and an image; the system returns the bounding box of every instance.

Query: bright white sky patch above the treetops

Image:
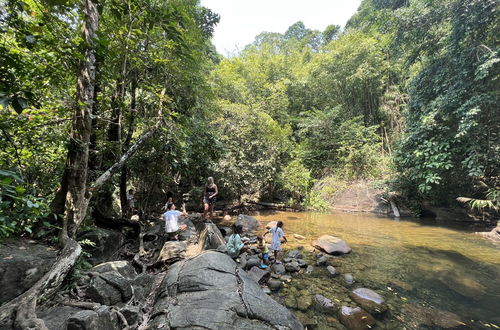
[201,0,361,56]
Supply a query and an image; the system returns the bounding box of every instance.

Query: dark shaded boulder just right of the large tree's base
[78,227,125,264]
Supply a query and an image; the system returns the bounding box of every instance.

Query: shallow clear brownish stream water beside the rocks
[256,212,500,329]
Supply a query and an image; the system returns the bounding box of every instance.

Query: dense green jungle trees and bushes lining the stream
[0,0,500,238]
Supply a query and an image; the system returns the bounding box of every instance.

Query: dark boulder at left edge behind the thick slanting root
[0,240,57,305]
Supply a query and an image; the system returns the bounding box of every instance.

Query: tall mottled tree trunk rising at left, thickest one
[60,0,99,246]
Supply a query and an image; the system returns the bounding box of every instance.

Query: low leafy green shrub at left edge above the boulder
[0,170,49,239]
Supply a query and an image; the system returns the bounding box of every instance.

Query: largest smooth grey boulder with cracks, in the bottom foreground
[148,251,303,329]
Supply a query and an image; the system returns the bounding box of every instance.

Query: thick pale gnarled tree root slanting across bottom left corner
[0,239,82,330]
